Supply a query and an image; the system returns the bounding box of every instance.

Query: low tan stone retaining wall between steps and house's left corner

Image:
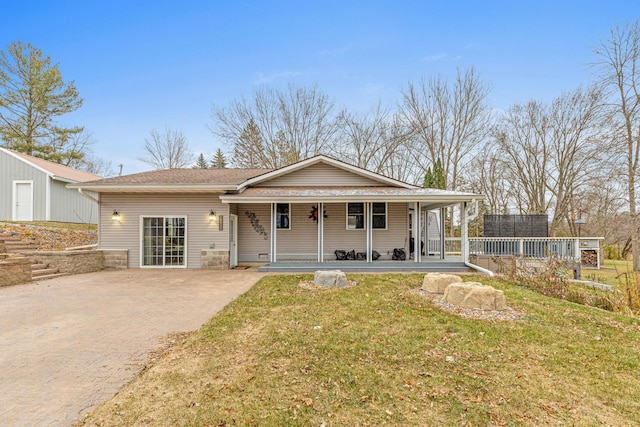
[21,250,104,274]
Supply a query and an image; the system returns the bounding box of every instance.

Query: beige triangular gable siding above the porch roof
[256,163,384,187]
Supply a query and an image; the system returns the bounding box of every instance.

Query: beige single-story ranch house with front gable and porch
[68,156,482,271]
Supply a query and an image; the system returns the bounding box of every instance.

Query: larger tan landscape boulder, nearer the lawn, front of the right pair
[444,282,507,310]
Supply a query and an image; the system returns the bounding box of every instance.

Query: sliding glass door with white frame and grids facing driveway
[142,216,187,267]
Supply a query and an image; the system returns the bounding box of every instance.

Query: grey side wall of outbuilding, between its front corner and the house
[50,180,98,224]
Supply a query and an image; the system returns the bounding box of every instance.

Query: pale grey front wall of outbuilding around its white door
[0,151,48,221]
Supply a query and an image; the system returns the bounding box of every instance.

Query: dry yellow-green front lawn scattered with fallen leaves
[76,275,640,426]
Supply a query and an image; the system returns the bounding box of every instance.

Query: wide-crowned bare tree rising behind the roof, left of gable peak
[210,83,336,168]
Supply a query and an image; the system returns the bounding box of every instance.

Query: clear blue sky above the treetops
[0,0,640,173]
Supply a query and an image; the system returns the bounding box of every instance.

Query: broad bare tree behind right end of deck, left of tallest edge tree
[495,88,608,233]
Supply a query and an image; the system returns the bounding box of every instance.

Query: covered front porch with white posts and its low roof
[221,188,475,272]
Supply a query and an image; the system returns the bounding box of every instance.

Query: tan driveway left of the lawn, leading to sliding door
[0,269,264,426]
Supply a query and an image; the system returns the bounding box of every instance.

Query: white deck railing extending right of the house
[469,237,580,260]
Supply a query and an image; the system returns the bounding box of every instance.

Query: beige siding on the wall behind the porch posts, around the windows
[237,203,409,262]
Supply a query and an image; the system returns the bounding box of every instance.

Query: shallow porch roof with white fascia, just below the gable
[220,187,483,209]
